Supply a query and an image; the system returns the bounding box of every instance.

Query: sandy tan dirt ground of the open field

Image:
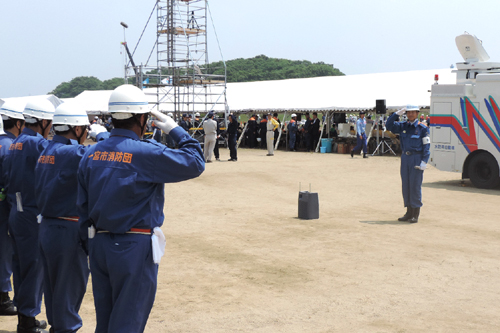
[0,149,500,333]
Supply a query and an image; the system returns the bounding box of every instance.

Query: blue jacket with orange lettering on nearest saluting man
[77,127,205,233]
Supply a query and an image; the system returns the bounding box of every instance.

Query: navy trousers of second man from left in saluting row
[9,206,43,317]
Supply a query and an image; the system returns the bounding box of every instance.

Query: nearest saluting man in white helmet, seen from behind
[77,85,205,333]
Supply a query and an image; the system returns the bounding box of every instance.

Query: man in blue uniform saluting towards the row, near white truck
[386,105,431,223]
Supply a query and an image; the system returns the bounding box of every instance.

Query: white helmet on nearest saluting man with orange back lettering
[108,84,149,119]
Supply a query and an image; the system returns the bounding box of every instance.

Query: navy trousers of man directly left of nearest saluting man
[40,217,89,332]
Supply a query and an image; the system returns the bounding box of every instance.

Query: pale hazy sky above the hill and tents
[0,0,500,98]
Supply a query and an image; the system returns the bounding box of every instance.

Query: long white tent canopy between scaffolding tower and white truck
[227,69,456,112]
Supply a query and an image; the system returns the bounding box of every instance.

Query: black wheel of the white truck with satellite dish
[469,153,500,189]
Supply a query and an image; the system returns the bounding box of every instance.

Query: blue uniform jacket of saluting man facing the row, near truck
[385,113,431,163]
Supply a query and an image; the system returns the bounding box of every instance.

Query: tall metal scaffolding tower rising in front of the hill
[126,0,227,117]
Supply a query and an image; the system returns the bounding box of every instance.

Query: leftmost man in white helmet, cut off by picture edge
[0,101,25,316]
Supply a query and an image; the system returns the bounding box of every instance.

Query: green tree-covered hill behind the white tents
[49,55,344,98]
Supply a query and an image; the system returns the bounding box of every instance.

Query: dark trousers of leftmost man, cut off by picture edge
[0,200,13,293]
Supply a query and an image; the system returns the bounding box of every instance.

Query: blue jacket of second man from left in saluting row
[2,128,49,209]
